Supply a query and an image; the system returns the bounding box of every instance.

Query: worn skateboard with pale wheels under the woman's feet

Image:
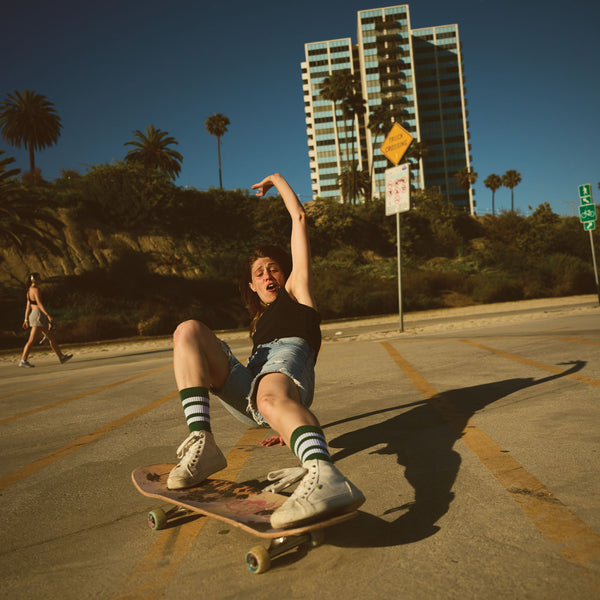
[131,464,358,574]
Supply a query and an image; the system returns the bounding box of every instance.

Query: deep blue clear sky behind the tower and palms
[0,0,600,215]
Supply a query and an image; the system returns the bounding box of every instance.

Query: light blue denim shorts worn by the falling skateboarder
[211,337,315,427]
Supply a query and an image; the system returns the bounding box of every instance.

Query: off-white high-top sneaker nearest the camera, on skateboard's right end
[271,459,365,529]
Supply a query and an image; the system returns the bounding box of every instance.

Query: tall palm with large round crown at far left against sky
[0,90,62,174]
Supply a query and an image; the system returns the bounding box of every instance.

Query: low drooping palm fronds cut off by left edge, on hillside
[0,150,63,253]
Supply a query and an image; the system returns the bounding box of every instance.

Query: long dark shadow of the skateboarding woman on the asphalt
[325,361,586,547]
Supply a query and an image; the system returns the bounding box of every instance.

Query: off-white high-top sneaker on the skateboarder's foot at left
[167,431,227,490]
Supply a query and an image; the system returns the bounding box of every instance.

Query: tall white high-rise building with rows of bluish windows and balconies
[302,5,475,213]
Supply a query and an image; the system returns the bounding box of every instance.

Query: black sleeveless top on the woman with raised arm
[252,288,321,361]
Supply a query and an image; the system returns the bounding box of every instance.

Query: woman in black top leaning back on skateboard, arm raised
[167,174,365,528]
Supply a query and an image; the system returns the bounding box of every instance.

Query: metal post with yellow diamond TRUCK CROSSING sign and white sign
[380,123,414,332]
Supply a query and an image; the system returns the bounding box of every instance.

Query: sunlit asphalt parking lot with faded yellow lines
[0,297,600,600]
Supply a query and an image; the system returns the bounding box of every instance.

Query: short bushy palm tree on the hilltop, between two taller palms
[123,125,183,179]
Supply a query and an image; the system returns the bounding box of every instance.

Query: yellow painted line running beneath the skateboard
[112,428,265,600]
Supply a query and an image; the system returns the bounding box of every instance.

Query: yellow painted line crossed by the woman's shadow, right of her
[382,340,600,563]
